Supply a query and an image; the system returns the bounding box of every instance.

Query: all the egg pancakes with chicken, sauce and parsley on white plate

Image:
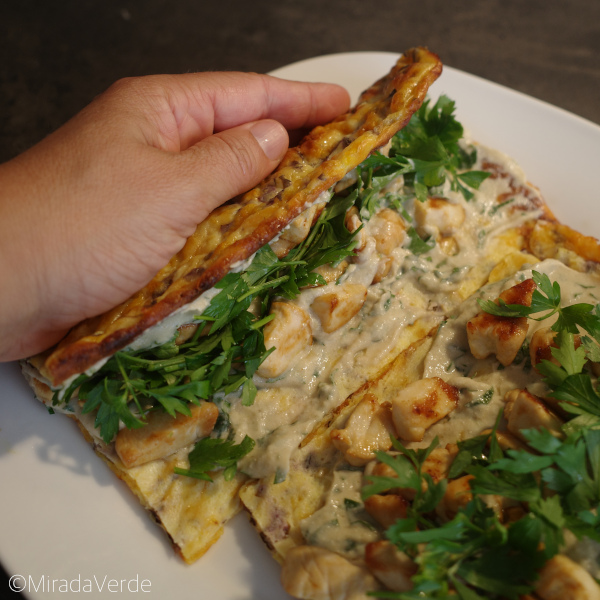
[17,42,600,600]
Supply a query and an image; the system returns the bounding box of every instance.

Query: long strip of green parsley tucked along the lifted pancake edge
[53,96,488,482]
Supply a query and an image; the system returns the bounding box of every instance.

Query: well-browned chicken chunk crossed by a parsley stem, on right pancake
[467,279,536,367]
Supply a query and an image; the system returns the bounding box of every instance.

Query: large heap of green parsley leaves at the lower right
[363,273,600,600]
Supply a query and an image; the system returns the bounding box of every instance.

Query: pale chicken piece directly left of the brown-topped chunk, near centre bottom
[330,393,394,467]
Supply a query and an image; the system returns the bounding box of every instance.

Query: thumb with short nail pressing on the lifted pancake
[177,119,289,222]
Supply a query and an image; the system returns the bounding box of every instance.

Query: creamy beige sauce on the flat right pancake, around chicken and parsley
[301,260,600,578]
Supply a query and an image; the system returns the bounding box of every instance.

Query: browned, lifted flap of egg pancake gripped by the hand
[34,48,442,386]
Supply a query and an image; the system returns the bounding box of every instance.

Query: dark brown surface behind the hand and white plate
[0,0,600,597]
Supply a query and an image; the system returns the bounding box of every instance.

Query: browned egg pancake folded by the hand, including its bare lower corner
[23,48,441,562]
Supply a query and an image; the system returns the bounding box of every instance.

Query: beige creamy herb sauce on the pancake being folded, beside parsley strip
[227,148,556,477]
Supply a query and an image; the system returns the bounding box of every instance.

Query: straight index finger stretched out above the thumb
[104,73,350,151]
